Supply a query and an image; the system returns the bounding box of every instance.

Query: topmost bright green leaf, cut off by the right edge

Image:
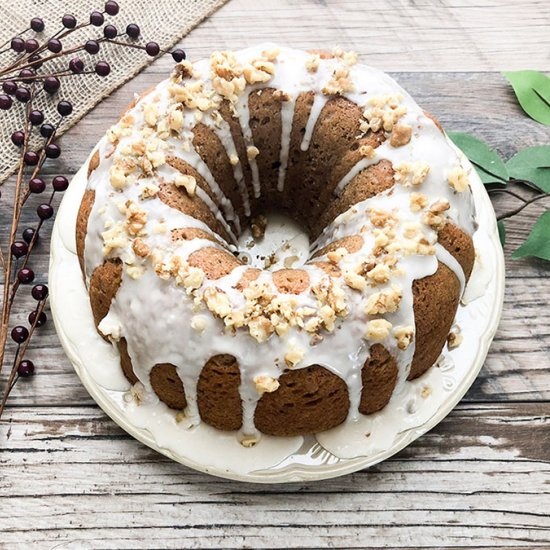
[502,71,550,126]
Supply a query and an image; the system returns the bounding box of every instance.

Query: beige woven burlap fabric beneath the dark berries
[0,0,227,184]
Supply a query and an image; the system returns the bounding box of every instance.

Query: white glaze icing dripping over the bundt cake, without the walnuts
[81,45,474,444]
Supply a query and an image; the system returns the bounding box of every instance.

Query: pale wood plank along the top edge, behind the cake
[164,0,550,71]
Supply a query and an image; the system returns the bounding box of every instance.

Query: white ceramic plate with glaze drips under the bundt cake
[50,144,504,483]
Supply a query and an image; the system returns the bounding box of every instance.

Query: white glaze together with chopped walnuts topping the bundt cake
[85,44,474,440]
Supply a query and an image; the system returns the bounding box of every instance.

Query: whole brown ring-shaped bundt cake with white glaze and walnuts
[76,45,475,444]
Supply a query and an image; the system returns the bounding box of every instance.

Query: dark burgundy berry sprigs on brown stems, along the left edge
[0,0,185,417]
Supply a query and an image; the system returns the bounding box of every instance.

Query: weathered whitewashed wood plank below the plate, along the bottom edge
[0,403,550,548]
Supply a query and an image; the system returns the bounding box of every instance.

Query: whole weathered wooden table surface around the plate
[0,0,550,549]
